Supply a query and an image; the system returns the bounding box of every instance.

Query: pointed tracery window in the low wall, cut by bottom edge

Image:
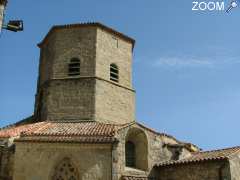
[52,158,79,180]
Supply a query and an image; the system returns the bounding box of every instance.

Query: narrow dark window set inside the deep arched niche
[125,141,136,167]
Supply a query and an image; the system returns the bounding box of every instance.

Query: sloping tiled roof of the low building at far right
[157,147,240,167]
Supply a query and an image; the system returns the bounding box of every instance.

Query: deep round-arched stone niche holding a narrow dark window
[125,127,148,170]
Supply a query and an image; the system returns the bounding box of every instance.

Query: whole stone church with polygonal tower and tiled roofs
[0,23,240,180]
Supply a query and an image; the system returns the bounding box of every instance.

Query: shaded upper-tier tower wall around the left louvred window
[53,27,96,79]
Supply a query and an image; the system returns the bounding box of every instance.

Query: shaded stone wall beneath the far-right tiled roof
[157,161,231,180]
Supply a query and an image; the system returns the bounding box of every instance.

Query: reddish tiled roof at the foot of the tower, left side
[0,121,122,142]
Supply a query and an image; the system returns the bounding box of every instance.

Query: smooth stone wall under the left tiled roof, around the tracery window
[13,142,111,180]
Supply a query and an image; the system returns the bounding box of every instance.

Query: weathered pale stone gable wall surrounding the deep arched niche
[112,123,181,180]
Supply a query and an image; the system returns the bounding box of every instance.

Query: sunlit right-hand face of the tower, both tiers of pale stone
[95,28,135,123]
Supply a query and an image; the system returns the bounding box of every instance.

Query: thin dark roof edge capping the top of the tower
[37,21,135,47]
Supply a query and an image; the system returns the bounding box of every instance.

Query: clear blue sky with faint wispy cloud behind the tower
[0,0,240,149]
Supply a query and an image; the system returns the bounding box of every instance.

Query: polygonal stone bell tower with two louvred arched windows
[35,23,135,124]
